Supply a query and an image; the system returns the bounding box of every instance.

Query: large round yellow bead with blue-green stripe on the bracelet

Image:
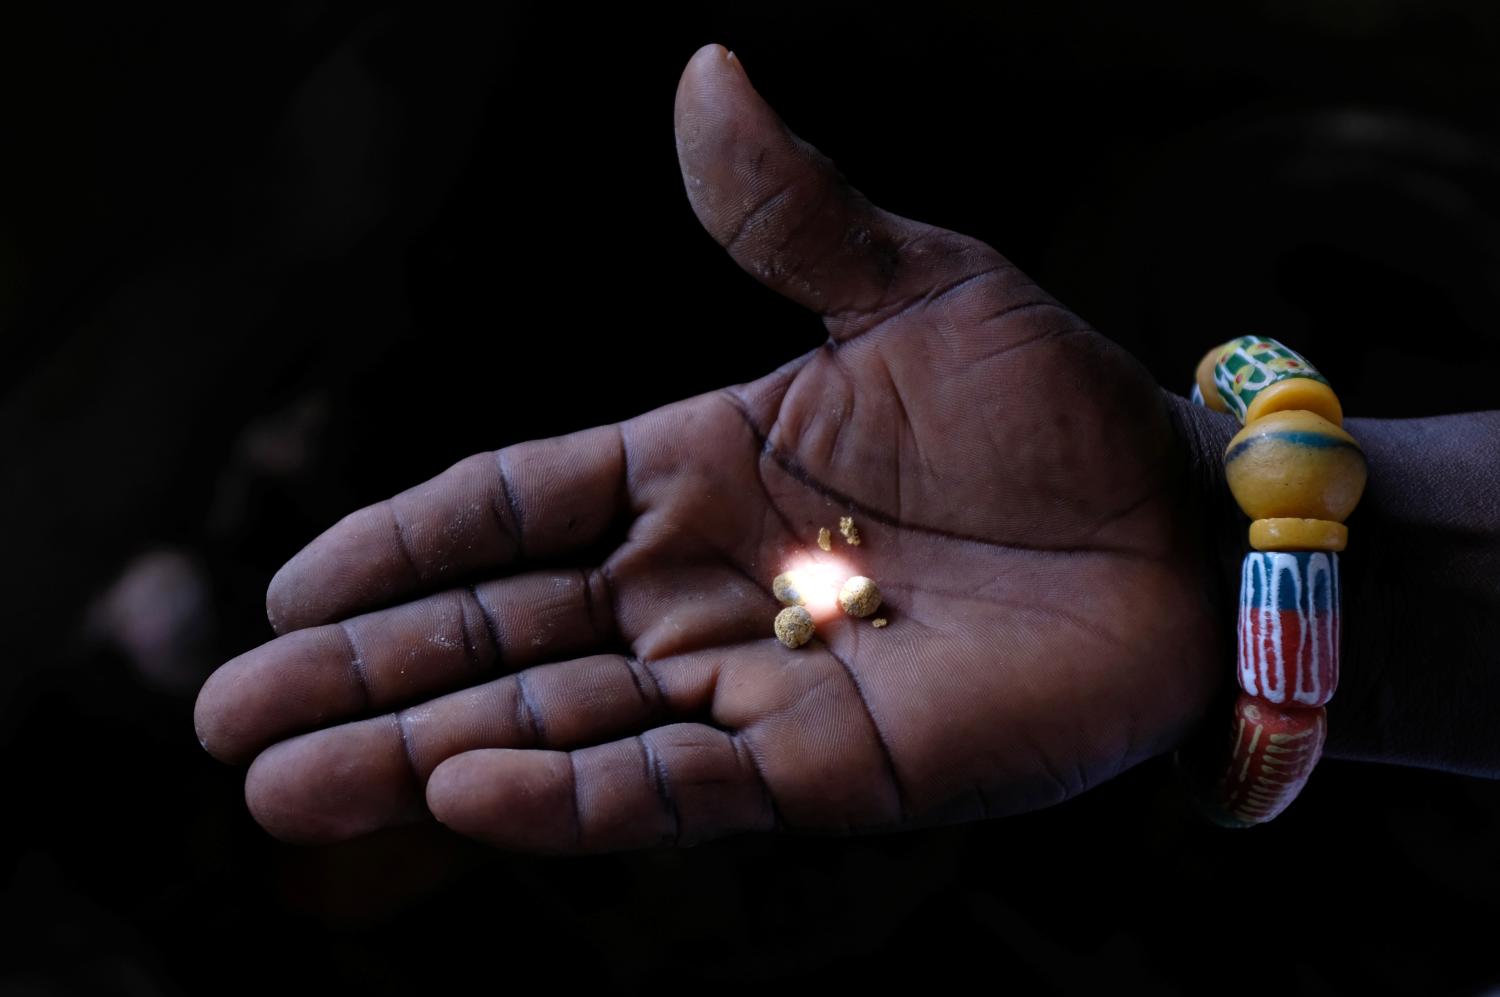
[1224,411,1365,522]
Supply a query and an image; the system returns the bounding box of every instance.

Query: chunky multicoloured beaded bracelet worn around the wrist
[1193,336,1365,828]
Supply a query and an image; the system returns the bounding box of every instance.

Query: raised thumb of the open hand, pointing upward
[677,45,1019,339]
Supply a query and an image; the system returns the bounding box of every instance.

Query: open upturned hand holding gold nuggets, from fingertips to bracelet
[197,40,1500,852]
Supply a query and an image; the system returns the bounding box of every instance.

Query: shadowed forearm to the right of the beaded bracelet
[1326,412,1500,775]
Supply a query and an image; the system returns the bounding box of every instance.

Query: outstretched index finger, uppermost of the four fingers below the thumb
[266,426,630,634]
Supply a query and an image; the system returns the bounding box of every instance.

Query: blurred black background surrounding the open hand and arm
[0,0,1500,994]
